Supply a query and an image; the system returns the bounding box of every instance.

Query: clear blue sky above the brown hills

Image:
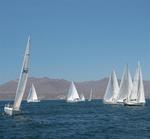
[0,0,150,84]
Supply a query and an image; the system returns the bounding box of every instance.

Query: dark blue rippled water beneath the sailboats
[0,100,150,139]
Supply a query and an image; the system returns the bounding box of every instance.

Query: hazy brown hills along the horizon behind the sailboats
[0,77,150,99]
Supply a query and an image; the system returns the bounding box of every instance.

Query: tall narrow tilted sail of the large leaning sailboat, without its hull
[13,37,30,110]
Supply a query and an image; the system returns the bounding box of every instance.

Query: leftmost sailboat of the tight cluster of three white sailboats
[103,70,119,104]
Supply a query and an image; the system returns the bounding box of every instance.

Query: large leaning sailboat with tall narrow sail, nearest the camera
[4,37,30,115]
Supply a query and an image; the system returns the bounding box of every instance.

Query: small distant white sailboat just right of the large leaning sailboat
[27,84,40,103]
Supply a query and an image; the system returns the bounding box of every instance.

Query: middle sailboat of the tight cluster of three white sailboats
[117,65,132,104]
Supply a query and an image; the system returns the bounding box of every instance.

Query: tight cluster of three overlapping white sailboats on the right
[103,63,145,106]
